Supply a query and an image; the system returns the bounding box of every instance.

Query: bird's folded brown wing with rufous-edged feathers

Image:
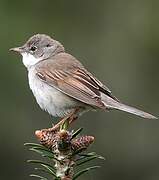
[37,64,117,108]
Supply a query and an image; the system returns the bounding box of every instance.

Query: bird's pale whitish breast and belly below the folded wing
[28,68,82,117]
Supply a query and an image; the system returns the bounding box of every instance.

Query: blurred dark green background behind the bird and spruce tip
[0,0,159,180]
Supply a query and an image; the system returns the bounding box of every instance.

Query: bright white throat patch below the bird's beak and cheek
[22,53,41,69]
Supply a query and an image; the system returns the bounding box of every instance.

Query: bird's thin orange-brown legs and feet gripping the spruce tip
[50,108,79,131]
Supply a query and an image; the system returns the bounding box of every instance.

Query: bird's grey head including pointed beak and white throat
[10,34,65,67]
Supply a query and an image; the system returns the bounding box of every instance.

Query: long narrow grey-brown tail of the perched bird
[102,94,158,119]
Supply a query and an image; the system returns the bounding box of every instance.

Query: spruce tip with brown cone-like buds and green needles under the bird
[25,118,104,180]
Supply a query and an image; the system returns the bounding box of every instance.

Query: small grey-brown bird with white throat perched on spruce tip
[10,34,157,122]
